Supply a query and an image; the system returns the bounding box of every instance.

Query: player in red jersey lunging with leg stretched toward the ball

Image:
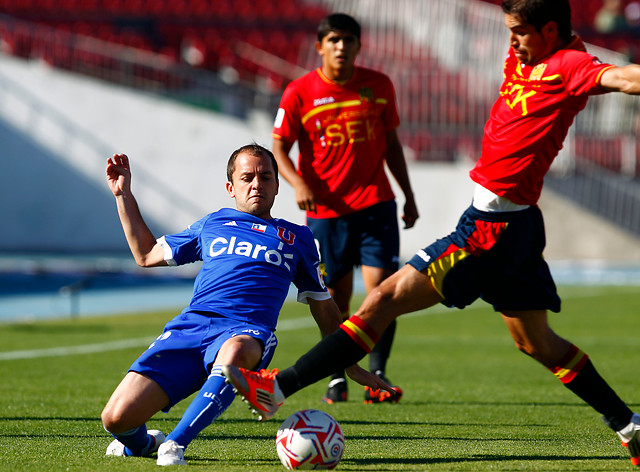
[223,0,640,465]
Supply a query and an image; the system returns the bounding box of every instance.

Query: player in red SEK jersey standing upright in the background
[273,13,418,403]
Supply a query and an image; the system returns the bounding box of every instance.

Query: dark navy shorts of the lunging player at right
[408,206,560,313]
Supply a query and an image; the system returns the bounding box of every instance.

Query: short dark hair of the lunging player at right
[502,0,572,41]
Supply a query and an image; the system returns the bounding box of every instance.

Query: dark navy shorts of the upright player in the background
[307,200,400,286]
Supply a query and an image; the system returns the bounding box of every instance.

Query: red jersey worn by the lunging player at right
[470,37,614,205]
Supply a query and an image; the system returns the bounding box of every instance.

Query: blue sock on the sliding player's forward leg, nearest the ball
[167,365,235,447]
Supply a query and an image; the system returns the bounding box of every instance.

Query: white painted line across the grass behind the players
[0,289,632,361]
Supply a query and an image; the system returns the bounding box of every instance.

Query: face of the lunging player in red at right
[505,14,557,65]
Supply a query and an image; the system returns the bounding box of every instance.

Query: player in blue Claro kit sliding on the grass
[102,144,381,466]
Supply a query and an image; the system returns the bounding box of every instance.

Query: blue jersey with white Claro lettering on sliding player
[158,208,330,330]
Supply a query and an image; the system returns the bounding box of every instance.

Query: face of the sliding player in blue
[227,152,278,218]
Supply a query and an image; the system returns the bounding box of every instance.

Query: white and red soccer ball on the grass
[276,410,344,470]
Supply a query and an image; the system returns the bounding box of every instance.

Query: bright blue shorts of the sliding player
[129,312,278,411]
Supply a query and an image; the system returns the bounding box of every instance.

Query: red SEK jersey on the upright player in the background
[273,67,400,218]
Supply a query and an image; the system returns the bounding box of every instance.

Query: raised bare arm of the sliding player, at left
[106,154,167,267]
